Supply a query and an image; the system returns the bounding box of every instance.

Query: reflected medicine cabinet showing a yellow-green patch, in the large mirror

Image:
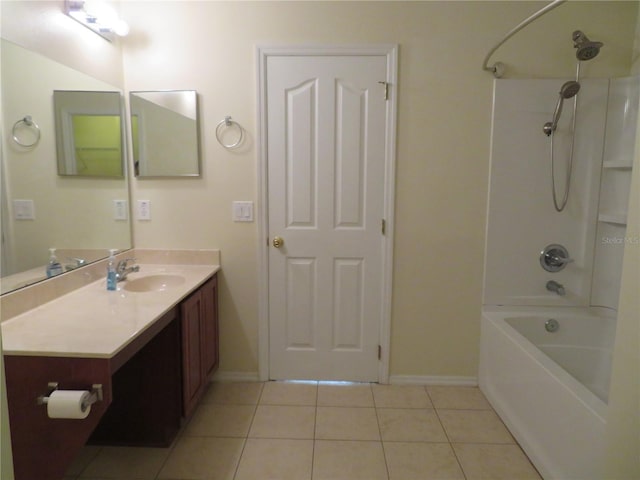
[53,90,124,177]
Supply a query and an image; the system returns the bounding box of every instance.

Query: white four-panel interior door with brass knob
[265,51,388,381]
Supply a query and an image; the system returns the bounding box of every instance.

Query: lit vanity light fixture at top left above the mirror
[65,0,129,42]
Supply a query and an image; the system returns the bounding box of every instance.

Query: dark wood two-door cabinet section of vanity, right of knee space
[180,275,219,418]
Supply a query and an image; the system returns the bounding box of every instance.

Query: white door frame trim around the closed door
[256,44,398,383]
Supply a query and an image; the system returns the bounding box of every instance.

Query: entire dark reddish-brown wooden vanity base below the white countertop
[0,274,219,480]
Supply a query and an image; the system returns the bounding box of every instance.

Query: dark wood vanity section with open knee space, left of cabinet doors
[4,309,182,480]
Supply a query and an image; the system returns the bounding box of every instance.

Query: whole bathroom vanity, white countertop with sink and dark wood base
[2,258,219,480]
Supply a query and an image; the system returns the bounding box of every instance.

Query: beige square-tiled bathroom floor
[65,382,540,480]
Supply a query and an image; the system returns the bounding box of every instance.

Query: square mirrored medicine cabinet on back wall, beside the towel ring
[129,90,200,177]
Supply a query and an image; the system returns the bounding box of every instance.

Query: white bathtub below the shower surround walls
[479,307,615,480]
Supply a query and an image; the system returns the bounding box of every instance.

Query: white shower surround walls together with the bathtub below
[479,78,640,480]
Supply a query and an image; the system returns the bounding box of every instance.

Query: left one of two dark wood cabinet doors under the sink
[181,291,204,417]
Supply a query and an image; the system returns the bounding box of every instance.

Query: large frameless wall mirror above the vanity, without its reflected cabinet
[0,39,132,293]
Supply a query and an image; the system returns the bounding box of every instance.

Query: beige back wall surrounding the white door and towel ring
[122,1,637,377]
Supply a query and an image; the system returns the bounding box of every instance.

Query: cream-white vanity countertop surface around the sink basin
[1,264,220,358]
